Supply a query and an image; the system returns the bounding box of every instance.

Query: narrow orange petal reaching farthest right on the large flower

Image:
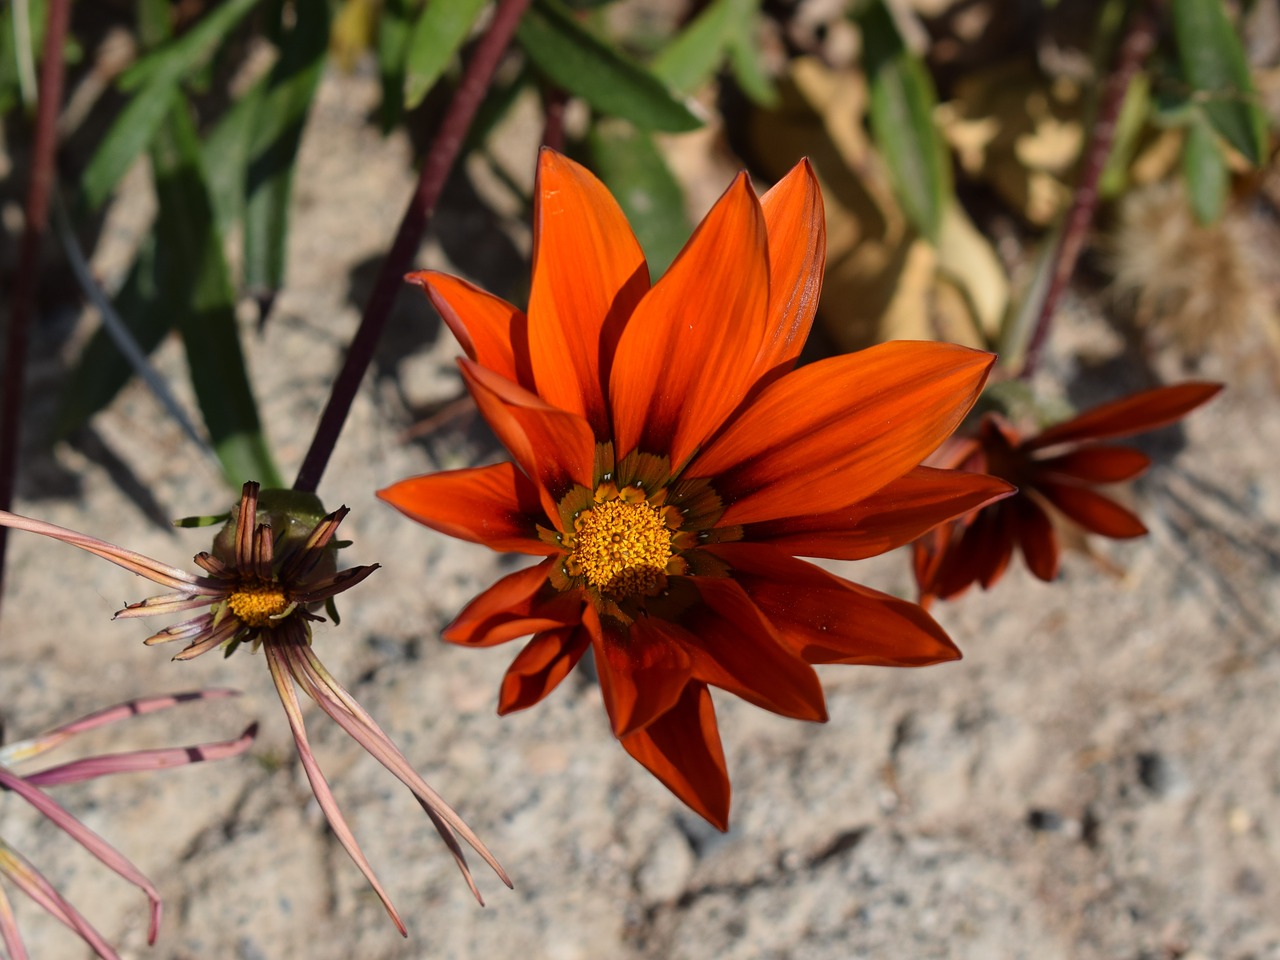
[742,467,1015,559]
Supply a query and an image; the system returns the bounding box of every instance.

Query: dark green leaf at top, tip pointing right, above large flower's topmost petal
[516,0,701,133]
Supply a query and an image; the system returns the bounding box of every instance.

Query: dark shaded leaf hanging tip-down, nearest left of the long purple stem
[244,0,329,298]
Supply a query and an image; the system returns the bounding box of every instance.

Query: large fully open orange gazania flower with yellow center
[379,150,1010,829]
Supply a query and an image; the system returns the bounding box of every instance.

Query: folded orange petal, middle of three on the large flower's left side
[458,360,595,520]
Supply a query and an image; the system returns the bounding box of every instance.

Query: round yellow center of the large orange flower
[566,499,672,600]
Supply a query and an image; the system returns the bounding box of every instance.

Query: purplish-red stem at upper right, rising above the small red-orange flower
[1019,0,1161,380]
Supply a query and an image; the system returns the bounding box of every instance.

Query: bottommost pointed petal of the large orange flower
[622,684,730,831]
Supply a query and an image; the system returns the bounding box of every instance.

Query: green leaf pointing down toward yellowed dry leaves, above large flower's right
[859,1,951,244]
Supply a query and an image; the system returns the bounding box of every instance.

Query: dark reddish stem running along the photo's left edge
[0,0,70,616]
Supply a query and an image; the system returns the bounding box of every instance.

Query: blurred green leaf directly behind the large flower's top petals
[588,119,692,273]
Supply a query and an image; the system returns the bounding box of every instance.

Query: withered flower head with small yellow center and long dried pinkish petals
[0,483,511,936]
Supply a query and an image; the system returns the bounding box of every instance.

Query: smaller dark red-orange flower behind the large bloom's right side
[914,383,1222,604]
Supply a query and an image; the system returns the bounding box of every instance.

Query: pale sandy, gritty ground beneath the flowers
[0,67,1280,960]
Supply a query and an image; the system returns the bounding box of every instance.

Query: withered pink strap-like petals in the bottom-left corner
[0,690,257,960]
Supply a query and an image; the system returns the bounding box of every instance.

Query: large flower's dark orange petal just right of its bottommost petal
[675,577,827,723]
